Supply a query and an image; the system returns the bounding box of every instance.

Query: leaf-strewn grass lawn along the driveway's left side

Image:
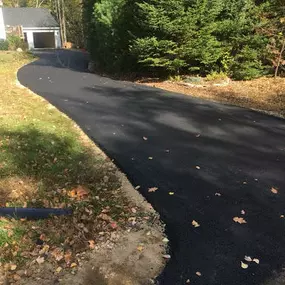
[0,52,134,283]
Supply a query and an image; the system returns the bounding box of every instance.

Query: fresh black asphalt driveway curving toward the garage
[18,51,285,285]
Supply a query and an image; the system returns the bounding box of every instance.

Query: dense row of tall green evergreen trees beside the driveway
[84,0,281,79]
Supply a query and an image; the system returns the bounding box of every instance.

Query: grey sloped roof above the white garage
[2,8,59,28]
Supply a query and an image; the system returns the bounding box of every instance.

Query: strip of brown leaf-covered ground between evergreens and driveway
[140,77,285,117]
